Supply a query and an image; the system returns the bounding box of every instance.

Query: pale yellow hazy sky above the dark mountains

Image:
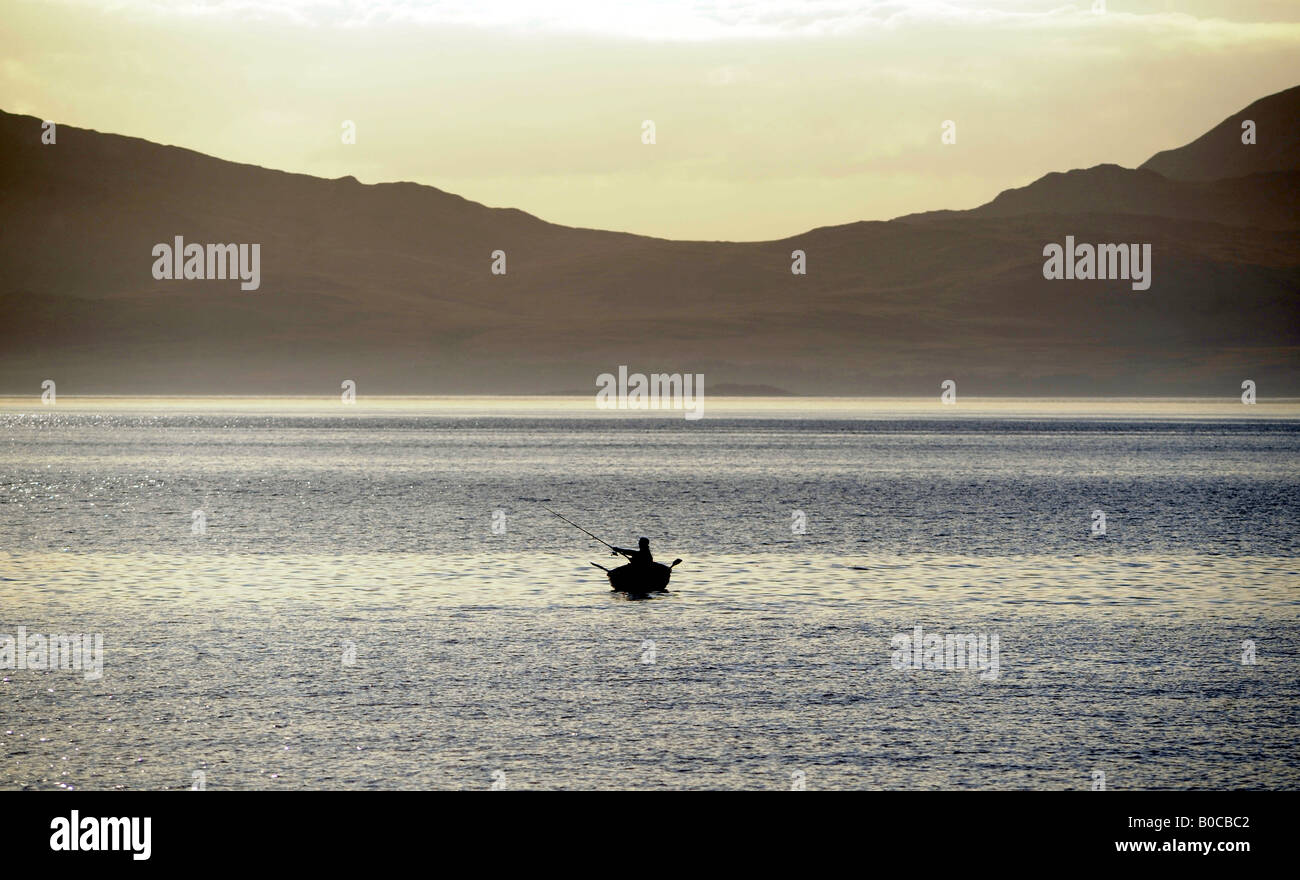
[0,0,1300,240]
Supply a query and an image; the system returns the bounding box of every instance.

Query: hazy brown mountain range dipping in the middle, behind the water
[0,88,1300,395]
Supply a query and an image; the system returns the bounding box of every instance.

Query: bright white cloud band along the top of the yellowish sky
[45,0,1297,42]
